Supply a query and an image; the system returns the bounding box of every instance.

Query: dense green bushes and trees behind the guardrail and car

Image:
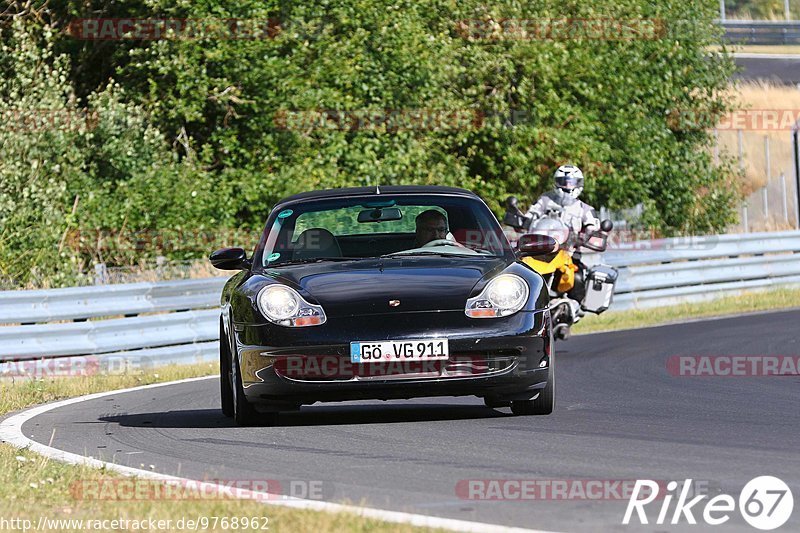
[0,0,736,286]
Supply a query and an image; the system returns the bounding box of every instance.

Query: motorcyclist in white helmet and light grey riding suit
[525,165,600,235]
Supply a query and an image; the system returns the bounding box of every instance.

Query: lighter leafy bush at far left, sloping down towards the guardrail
[0,22,216,285]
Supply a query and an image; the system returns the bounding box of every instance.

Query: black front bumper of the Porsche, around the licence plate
[234,311,552,407]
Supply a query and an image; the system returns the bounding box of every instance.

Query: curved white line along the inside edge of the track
[0,376,564,533]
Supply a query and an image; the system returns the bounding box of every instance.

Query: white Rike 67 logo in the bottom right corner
[622,476,794,531]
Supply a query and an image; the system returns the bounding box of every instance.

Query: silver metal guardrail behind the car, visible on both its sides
[0,231,800,377]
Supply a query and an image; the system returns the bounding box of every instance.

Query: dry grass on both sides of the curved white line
[0,364,432,533]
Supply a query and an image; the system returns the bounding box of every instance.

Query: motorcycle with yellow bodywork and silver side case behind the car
[503,196,618,340]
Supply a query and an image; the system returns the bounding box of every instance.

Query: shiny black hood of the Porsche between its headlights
[268,256,508,317]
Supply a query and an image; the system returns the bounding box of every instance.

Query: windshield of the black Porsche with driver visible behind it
[256,195,513,267]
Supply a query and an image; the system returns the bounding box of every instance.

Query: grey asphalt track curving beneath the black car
[17,310,800,532]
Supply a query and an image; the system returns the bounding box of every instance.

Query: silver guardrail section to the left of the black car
[0,278,227,377]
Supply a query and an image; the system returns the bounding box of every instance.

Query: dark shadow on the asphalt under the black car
[99,403,511,428]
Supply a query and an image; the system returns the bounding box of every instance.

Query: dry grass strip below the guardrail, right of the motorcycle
[573,289,800,334]
